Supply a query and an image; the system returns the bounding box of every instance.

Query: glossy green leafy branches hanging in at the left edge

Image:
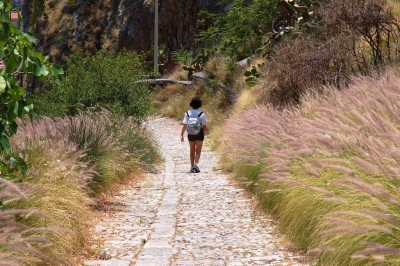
[0,0,63,178]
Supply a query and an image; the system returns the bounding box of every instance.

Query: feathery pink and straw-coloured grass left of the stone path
[0,110,160,265]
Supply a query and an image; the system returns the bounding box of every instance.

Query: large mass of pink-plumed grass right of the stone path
[218,67,400,265]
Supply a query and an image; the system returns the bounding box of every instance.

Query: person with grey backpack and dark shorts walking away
[181,97,207,173]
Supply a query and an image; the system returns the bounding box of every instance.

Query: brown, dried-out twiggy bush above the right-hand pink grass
[257,34,355,108]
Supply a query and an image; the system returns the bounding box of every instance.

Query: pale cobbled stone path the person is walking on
[85,118,308,266]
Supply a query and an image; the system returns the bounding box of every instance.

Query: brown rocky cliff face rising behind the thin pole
[23,0,229,61]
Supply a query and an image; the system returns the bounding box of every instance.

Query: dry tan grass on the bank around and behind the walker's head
[152,52,250,149]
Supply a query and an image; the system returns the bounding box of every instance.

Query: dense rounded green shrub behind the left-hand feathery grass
[34,51,150,122]
